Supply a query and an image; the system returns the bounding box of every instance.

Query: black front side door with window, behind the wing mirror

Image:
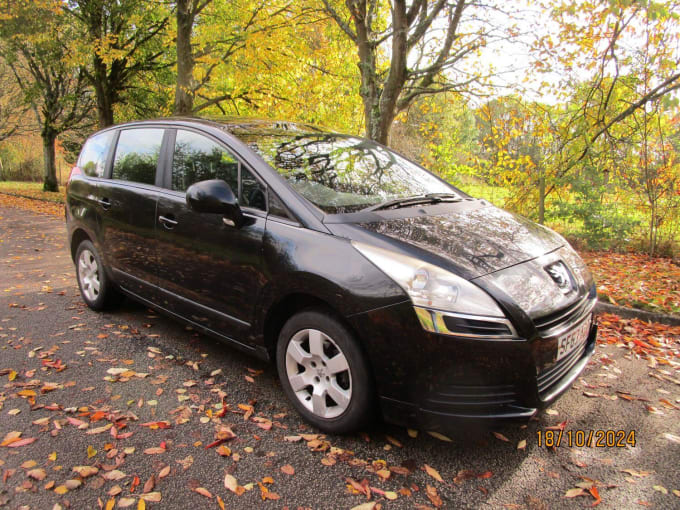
[156,129,267,343]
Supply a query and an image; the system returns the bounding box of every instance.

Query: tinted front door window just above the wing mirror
[172,130,238,194]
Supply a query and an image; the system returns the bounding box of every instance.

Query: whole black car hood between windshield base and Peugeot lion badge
[328,200,565,279]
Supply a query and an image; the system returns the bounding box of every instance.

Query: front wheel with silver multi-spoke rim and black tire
[276,310,375,434]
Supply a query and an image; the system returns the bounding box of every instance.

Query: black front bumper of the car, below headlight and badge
[351,303,597,431]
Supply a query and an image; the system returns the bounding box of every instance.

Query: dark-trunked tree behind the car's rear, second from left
[63,0,170,128]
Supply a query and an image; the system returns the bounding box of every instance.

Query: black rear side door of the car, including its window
[98,127,166,299]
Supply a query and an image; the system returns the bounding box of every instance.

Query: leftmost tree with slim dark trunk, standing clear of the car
[0,0,92,191]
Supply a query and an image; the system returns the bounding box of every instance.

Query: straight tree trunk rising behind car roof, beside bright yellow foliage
[174,0,194,115]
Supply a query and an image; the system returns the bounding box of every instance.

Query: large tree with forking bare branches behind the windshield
[323,0,502,143]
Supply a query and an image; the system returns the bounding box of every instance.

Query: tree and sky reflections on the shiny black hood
[360,201,564,278]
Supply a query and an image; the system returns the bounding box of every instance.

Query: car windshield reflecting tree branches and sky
[232,129,464,214]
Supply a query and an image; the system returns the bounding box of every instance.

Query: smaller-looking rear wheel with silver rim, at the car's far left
[75,241,122,311]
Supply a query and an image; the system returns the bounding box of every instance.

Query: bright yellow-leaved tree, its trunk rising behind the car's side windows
[173,0,326,115]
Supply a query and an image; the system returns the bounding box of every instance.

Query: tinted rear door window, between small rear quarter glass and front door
[113,129,163,184]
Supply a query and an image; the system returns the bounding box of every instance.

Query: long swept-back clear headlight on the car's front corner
[352,241,516,338]
